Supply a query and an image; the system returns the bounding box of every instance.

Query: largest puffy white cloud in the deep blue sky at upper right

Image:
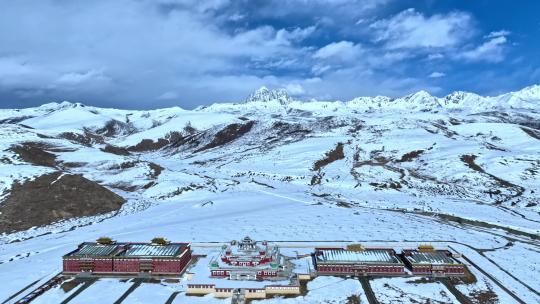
[370,8,472,49]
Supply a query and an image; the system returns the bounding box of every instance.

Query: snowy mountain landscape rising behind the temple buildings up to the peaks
[0,86,540,299]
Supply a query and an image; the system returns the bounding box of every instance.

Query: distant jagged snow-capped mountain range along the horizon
[9,84,540,112]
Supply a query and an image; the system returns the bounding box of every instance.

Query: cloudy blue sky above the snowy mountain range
[0,0,540,109]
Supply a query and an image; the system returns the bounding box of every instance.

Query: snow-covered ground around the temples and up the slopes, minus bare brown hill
[0,87,540,303]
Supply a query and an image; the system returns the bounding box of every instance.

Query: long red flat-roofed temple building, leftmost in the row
[63,240,191,275]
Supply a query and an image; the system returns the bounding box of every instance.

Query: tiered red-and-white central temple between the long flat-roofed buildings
[186,237,311,299]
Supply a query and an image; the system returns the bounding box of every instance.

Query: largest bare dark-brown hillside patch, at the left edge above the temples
[0,172,125,233]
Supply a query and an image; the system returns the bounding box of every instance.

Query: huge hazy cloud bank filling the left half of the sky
[0,0,317,107]
